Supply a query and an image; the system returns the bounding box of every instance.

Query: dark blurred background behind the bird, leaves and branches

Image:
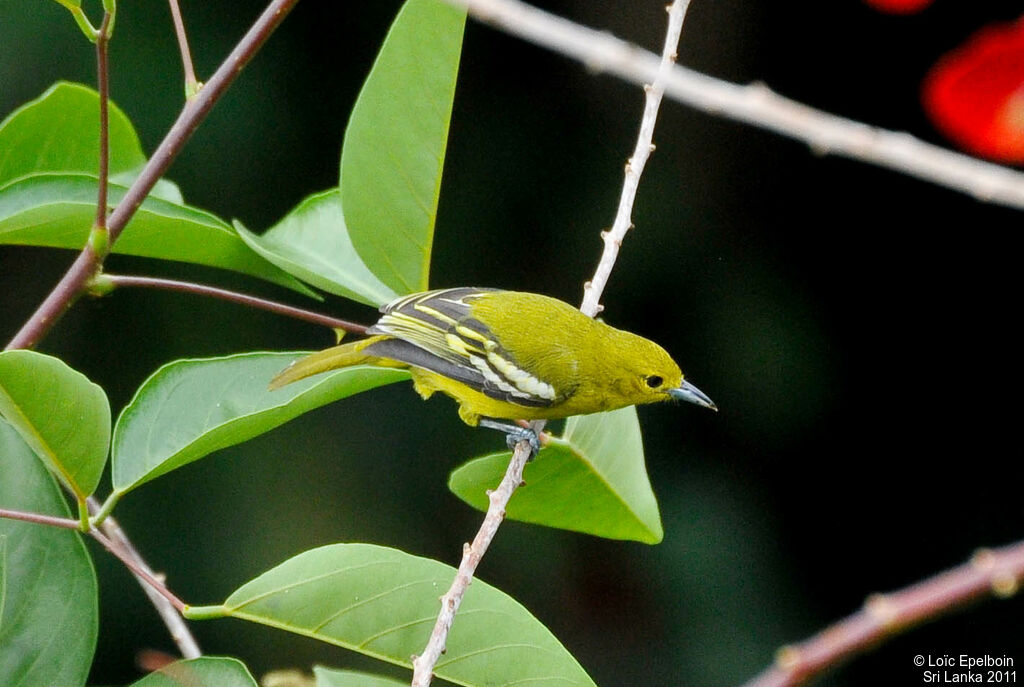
[0,0,1024,685]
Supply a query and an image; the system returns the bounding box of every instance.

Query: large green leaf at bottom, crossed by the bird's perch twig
[200,544,594,685]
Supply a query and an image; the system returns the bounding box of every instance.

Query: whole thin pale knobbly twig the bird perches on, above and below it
[412,0,689,687]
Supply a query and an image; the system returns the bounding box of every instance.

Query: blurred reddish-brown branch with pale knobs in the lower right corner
[745,542,1024,687]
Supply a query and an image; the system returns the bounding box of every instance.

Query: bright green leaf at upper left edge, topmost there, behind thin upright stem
[0,81,145,185]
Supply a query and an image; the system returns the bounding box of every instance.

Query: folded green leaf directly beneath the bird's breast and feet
[449,406,664,544]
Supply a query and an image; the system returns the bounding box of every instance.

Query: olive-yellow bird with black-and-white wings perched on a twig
[270,287,718,449]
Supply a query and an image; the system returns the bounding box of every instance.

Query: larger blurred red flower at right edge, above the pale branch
[922,19,1024,164]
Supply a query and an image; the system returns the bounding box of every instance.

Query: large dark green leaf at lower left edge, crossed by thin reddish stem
[0,420,98,687]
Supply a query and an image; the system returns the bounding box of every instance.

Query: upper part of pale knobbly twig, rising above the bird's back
[580,0,690,317]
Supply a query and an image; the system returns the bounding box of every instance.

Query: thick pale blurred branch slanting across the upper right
[447,0,1024,209]
